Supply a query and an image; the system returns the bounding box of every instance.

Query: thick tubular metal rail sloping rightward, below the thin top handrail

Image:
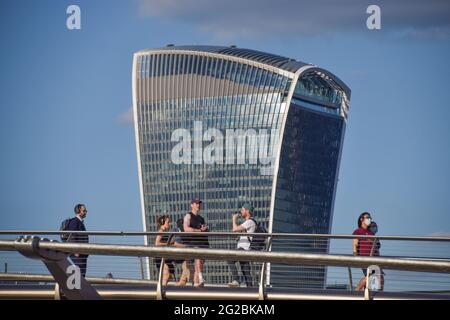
[0,240,450,273]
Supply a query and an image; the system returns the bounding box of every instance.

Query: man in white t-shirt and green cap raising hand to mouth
[228,203,256,287]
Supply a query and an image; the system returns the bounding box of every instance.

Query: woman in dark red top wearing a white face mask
[353,212,375,291]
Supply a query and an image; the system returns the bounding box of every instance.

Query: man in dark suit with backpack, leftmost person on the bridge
[61,203,89,277]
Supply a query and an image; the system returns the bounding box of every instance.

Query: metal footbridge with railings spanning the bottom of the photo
[0,230,450,300]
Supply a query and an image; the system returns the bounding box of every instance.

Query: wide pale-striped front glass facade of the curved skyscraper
[136,50,291,283]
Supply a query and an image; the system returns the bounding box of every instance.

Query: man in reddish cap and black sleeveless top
[183,198,209,287]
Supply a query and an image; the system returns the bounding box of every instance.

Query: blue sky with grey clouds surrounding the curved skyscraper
[0,0,450,235]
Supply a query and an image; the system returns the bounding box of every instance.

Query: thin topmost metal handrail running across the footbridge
[0,230,450,242]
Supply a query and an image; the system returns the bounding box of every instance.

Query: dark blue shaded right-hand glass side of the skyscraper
[271,100,344,288]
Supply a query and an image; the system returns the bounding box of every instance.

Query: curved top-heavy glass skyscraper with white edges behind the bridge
[133,46,350,287]
